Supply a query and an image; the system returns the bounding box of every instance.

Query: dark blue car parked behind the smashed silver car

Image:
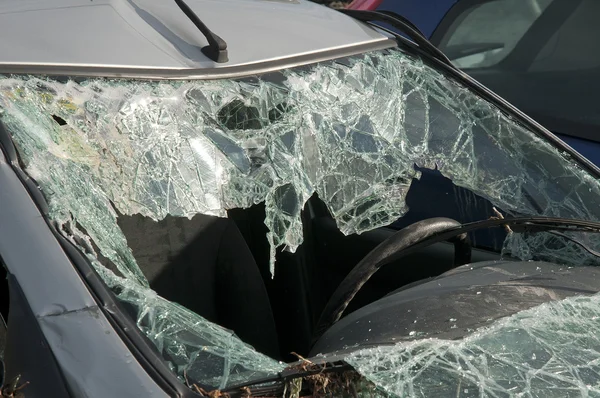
[349,0,600,165]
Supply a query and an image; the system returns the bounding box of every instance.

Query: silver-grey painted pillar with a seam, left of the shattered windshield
[0,151,167,397]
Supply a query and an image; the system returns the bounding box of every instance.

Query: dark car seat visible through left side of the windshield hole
[118,214,279,358]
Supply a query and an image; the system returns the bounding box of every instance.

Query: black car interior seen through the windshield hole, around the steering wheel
[113,169,505,361]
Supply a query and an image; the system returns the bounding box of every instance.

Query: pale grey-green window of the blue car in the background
[439,0,553,69]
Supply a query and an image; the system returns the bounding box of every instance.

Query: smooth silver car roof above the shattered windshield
[0,0,391,75]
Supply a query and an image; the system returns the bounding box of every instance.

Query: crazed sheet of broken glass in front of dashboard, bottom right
[346,295,600,398]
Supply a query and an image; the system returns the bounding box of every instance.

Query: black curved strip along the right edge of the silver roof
[338,9,455,69]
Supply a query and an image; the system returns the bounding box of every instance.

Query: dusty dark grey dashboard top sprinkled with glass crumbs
[311,261,600,356]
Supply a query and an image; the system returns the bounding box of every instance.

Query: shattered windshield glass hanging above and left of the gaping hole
[0,45,600,396]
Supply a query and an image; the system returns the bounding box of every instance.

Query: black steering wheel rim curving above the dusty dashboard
[313,217,471,342]
